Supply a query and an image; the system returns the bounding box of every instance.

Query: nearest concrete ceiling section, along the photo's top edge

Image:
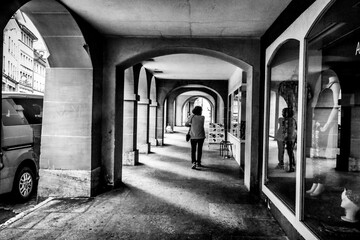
[60,0,291,37]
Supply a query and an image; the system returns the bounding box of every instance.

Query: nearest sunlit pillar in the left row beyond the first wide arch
[123,94,139,166]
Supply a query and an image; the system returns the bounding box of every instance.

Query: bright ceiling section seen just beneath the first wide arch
[143,54,237,80]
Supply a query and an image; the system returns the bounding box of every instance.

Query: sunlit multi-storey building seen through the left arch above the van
[2,11,47,94]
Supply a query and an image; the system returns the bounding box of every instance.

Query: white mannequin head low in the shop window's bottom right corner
[341,189,360,223]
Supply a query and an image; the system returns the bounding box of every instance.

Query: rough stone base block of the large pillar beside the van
[38,167,101,198]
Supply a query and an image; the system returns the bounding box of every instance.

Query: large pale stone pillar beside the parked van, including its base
[38,68,100,197]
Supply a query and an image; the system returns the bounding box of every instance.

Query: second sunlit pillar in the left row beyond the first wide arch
[137,99,150,154]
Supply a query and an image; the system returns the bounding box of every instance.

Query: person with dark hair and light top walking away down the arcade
[185,106,205,169]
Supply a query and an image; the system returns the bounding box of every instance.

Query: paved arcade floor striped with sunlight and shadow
[0,128,287,240]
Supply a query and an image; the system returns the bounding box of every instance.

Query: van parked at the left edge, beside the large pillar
[0,92,43,201]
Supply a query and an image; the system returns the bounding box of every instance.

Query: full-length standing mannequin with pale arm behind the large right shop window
[306,70,340,197]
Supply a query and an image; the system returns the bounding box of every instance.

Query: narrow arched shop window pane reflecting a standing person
[266,40,299,211]
